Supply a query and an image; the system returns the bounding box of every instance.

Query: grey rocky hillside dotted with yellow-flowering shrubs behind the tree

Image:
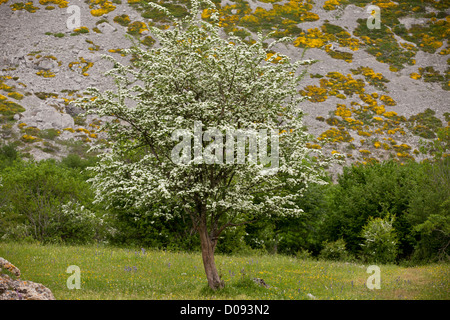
[0,0,450,169]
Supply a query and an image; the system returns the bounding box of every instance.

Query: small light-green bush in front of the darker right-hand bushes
[361,215,398,263]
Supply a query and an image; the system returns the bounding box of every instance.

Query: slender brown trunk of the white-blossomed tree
[198,225,224,290]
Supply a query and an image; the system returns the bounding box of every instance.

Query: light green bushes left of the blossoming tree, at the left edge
[0,157,100,243]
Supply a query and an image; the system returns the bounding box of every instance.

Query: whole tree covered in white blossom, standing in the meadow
[79,0,330,289]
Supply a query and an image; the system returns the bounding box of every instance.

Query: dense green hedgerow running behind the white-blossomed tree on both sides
[0,145,450,263]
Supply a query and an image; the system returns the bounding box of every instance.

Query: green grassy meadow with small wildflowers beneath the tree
[0,243,450,300]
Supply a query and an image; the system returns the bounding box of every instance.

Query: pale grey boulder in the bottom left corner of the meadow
[0,257,55,300]
